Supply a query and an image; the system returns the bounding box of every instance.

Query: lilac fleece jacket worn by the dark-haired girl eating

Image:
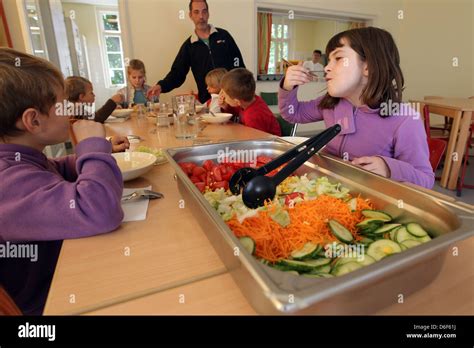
[278,87,434,189]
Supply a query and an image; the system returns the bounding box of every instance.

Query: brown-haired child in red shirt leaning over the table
[221,68,281,136]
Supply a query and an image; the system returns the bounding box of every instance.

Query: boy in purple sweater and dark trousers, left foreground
[0,48,123,314]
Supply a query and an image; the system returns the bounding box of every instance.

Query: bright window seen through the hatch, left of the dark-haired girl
[268,16,290,74]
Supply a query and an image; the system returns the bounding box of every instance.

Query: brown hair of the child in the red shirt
[221,68,256,102]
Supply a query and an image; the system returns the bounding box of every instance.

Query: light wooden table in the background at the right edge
[410,98,474,190]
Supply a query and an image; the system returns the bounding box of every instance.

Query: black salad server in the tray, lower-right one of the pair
[242,124,341,209]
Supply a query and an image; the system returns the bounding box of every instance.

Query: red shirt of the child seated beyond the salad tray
[240,96,281,136]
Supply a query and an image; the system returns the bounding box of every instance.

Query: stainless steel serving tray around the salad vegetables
[165,138,474,314]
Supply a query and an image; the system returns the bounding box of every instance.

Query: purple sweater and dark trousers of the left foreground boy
[0,138,123,314]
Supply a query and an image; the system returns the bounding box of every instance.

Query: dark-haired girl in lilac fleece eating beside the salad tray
[278,27,434,188]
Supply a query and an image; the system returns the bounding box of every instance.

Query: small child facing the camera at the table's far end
[117,59,158,108]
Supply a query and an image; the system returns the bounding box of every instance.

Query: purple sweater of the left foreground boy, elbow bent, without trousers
[2,137,123,242]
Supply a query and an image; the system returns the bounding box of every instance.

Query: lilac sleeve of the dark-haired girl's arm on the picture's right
[380,118,435,189]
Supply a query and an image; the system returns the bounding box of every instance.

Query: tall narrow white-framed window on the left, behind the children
[99,11,126,88]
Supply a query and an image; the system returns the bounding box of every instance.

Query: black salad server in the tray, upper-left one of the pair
[229,125,336,195]
